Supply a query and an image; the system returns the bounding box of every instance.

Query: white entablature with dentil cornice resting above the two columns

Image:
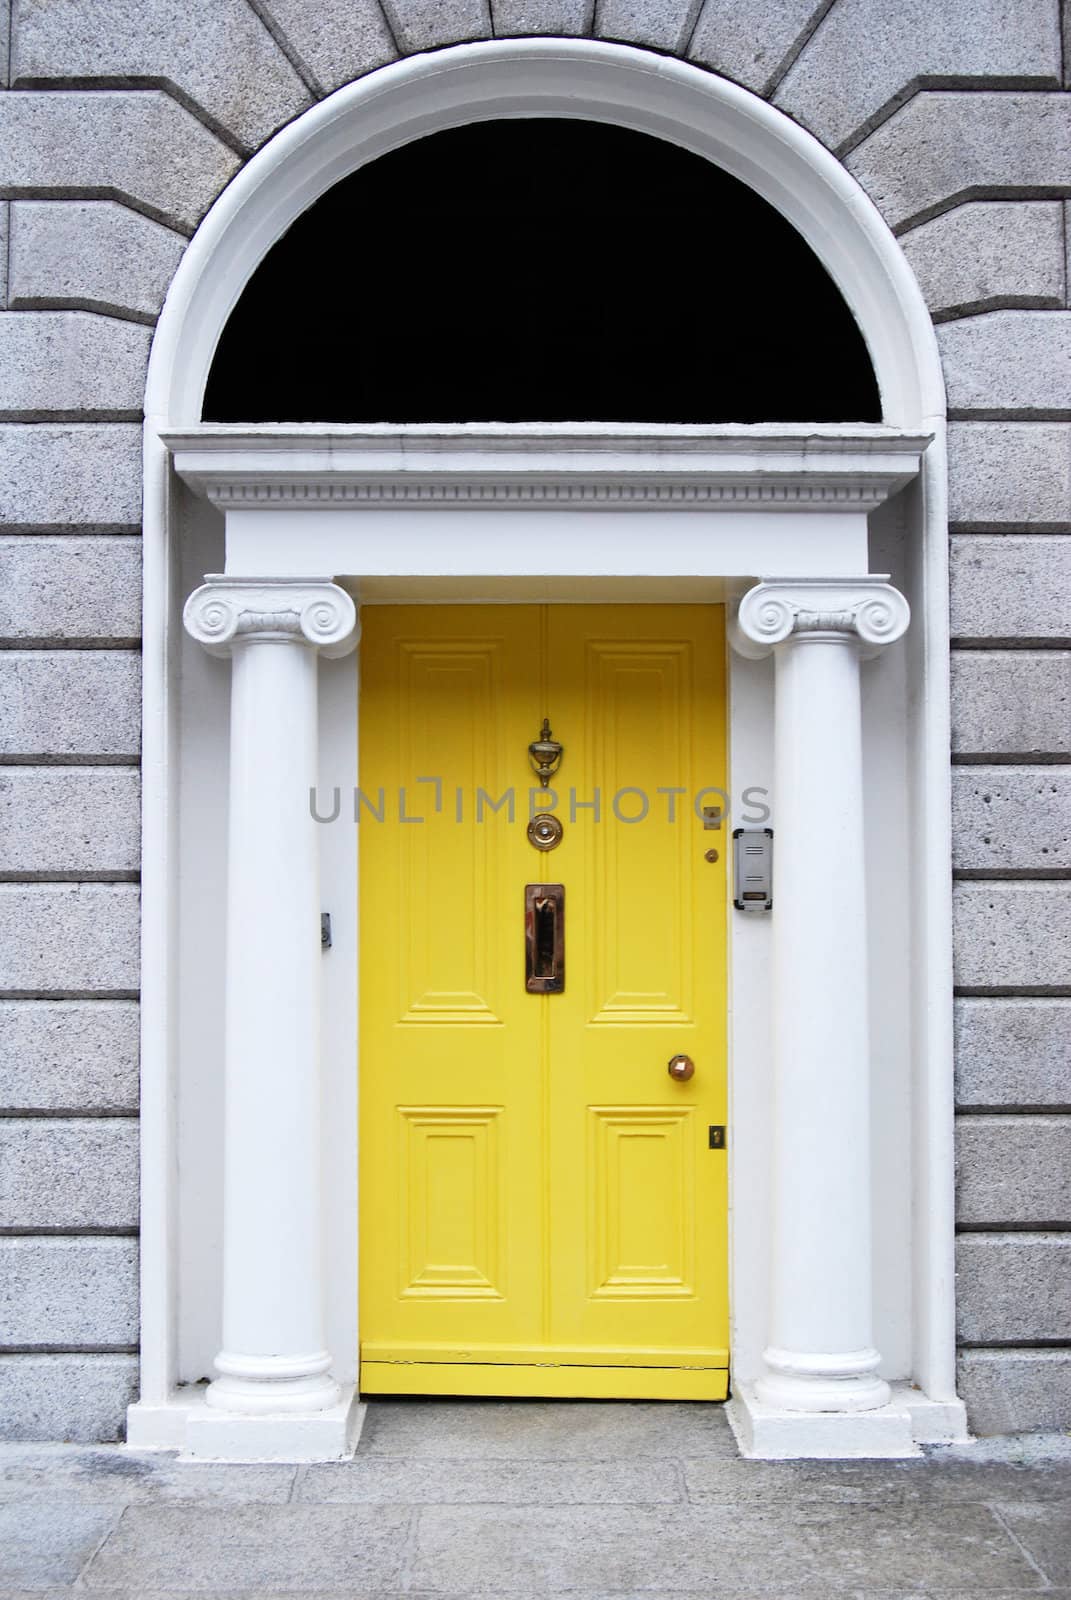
[165,424,929,579]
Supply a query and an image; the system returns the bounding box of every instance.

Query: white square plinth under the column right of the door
[725,1382,967,1461]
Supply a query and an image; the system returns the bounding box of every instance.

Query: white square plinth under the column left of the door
[126,1384,367,1461]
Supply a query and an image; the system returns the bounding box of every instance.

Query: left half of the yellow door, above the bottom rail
[359,606,544,1346]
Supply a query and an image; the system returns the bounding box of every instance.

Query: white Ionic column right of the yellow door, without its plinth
[735,578,909,1413]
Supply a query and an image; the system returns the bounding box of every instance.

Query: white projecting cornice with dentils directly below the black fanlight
[163,424,929,512]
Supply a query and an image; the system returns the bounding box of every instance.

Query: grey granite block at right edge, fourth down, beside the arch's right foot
[937,310,1071,416]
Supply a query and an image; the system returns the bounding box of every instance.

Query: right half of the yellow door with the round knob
[548,606,728,1369]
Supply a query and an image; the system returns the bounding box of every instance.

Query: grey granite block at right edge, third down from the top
[900,200,1066,318]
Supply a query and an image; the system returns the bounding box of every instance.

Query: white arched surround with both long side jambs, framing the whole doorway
[133,38,954,1443]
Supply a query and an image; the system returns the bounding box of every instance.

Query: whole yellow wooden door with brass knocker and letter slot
[359,605,728,1400]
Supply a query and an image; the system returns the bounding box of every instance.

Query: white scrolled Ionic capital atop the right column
[732,573,911,659]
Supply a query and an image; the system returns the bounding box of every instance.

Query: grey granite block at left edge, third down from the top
[8,200,186,322]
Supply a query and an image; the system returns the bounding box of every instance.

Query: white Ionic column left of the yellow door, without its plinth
[184,576,357,1416]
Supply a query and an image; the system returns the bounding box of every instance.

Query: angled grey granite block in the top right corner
[775,0,1060,150]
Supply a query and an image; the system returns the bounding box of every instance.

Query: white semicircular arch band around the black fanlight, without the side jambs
[146,38,943,429]
